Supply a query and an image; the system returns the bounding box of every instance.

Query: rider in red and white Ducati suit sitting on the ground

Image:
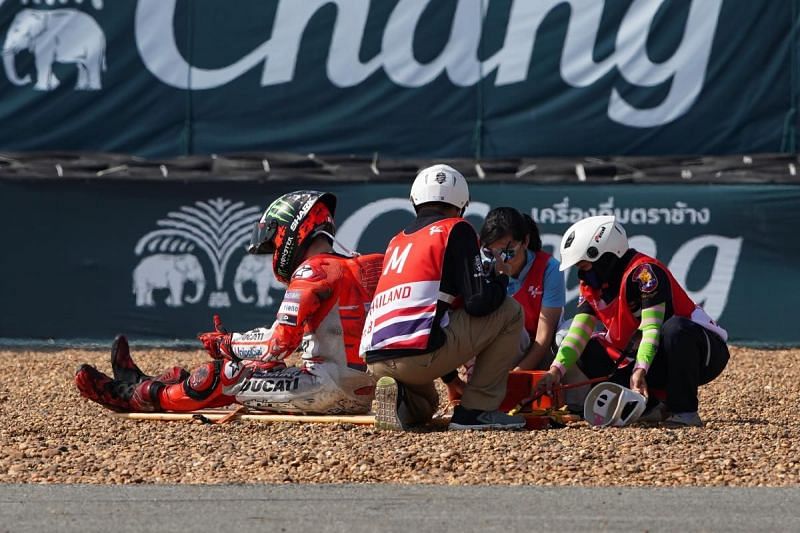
[75,191,383,414]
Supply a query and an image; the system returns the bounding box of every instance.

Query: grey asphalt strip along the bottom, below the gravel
[0,484,800,533]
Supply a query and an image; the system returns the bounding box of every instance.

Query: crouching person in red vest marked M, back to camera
[361,165,525,429]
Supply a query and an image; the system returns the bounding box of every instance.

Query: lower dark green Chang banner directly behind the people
[0,180,800,345]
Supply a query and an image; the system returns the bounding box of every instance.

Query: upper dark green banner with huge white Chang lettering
[0,0,800,158]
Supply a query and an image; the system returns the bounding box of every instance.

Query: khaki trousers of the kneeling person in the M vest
[369,298,523,425]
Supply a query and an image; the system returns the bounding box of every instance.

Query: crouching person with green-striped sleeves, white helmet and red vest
[538,216,729,426]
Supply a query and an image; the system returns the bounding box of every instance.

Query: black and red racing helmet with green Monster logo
[247,191,336,283]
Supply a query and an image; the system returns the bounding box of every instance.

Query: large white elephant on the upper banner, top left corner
[3,9,106,91]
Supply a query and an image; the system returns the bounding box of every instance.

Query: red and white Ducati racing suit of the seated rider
[159,254,383,414]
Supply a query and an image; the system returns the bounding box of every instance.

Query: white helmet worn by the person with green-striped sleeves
[561,216,629,271]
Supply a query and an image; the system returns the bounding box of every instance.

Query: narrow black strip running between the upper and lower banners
[0,152,800,186]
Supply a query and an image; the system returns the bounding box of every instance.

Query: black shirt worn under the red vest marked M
[367,208,508,363]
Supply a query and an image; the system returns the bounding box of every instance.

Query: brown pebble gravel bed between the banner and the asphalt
[0,348,800,486]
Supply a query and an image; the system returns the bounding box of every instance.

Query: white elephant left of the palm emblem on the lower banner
[133,254,206,307]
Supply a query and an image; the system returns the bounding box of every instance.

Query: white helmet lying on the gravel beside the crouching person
[583,381,647,427]
